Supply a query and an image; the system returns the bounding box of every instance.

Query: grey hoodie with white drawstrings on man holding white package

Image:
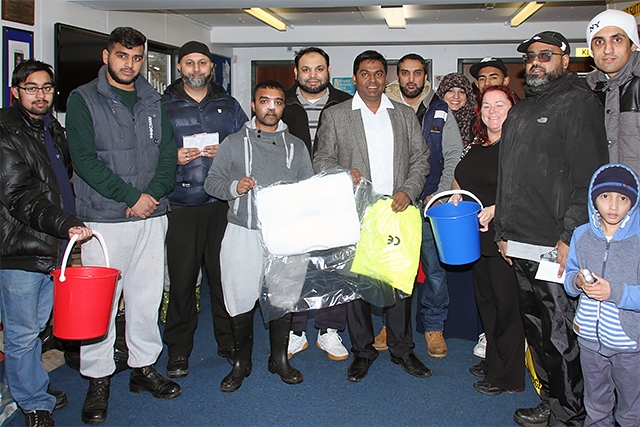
[204,117,313,230]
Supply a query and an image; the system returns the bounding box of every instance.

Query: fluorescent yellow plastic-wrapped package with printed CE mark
[351,198,422,294]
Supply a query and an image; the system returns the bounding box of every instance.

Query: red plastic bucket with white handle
[51,231,120,340]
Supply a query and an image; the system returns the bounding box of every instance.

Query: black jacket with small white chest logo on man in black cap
[495,72,609,246]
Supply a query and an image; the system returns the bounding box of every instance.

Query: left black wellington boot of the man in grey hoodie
[220,310,255,393]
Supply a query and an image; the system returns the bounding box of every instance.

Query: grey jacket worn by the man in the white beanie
[587,51,640,175]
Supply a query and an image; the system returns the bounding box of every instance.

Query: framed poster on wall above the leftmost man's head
[2,27,33,107]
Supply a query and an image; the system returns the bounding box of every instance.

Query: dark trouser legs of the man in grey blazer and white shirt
[347,297,415,360]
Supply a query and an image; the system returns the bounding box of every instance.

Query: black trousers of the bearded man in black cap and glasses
[513,258,585,426]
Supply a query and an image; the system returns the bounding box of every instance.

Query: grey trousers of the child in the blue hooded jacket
[580,346,640,427]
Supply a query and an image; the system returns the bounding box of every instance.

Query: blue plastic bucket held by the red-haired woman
[425,190,482,265]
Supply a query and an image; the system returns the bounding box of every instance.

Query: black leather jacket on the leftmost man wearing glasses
[0,104,84,273]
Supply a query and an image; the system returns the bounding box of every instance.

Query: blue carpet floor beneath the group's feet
[9,289,540,426]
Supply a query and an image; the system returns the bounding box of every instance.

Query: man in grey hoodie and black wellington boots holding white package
[204,80,313,392]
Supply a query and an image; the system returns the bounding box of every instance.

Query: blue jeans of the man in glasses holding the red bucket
[0,270,56,413]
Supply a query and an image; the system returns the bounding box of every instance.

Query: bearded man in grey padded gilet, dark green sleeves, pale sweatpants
[67,27,181,424]
